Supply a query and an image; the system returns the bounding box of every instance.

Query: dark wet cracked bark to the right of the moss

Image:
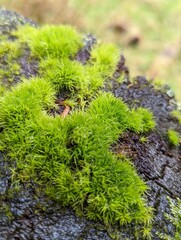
[113,77,181,239]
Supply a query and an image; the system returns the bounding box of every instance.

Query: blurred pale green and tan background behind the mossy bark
[0,0,181,101]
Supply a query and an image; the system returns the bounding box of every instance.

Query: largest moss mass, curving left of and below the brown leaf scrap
[0,84,151,236]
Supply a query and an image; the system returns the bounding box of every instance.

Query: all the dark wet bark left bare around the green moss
[0,9,181,240]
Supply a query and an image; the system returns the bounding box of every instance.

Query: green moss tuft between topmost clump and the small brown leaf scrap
[40,58,104,100]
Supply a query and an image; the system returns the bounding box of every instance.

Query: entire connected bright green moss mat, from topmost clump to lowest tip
[0,23,155,237]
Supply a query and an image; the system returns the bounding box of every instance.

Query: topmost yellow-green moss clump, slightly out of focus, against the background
[15,25,82,59]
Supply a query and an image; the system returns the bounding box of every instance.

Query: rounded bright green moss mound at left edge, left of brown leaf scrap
[0,78,55,128]
